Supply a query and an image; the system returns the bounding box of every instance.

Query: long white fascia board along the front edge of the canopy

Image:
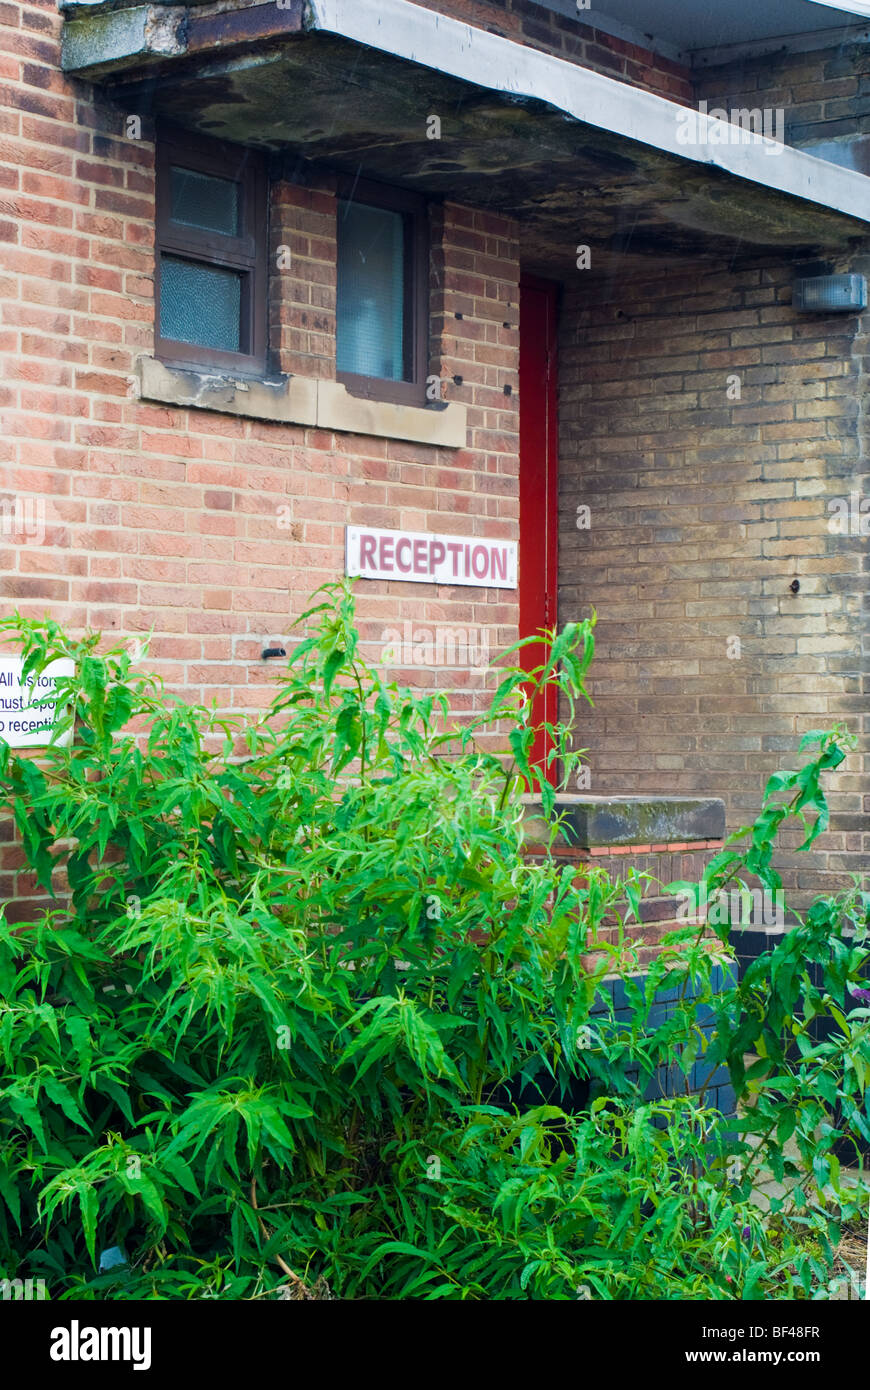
[309,0,870,222]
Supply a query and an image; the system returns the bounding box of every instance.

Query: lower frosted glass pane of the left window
[160,256,242,352]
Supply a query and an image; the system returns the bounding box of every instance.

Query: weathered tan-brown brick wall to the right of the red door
[560,248,870,891]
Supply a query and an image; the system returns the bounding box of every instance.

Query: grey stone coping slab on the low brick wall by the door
[524,792,725,849]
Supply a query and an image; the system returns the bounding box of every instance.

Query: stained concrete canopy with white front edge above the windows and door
[63,0,870,270]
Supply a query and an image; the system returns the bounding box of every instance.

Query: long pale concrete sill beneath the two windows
[135,357,466,449]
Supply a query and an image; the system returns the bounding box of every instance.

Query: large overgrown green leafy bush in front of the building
[0,588,870,1300]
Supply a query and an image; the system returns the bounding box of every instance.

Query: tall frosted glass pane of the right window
[338,203,404,381]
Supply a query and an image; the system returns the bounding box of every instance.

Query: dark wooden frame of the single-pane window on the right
[335,179,429,406]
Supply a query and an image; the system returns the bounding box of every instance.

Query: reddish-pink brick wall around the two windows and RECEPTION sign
[0,0,518,911]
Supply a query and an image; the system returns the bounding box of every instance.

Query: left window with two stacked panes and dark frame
[157,133,265,373]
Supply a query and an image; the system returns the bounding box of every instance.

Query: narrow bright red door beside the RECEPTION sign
[520,275,559,783]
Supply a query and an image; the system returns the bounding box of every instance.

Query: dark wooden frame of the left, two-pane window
[154,129,267,375]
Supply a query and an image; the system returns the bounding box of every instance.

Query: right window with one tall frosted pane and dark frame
[336,182,429,406]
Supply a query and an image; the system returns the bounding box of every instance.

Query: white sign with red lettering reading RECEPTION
[345,525,517,589]
